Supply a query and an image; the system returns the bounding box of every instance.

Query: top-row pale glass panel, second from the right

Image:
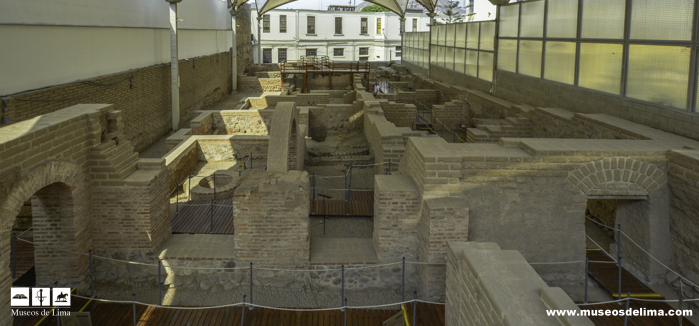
[582,0,626,39]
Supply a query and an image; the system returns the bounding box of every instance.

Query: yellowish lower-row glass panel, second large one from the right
[578,43,623,94]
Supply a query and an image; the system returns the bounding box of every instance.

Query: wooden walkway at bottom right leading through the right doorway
[580,249,694,326]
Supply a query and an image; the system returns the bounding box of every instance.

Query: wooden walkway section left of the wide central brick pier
[171,199,235,234]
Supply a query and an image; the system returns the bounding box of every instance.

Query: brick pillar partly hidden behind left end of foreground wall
[418,197,468,300]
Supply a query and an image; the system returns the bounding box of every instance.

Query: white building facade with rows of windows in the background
[251,9,430,63]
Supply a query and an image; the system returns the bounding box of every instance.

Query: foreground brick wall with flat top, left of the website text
[445,241,594,326]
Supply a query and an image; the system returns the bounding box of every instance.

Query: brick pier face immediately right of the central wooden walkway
[373,175,420,262]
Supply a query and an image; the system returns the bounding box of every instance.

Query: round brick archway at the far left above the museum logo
[0,161,91,293]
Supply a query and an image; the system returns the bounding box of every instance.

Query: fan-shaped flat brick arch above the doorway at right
[568,157,667,196]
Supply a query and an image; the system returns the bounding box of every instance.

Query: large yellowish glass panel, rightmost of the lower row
[626,45,691,109]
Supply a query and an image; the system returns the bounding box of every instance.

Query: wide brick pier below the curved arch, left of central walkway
[233,171,310,268]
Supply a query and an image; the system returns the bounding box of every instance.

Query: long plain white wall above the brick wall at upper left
[0,0,232,95]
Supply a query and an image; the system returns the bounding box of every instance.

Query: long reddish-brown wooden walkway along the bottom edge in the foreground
[14,297,444,326]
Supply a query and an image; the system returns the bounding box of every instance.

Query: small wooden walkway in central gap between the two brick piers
[310,189,374,216]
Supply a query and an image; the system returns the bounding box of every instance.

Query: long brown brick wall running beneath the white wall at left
[3,52,231,152]
